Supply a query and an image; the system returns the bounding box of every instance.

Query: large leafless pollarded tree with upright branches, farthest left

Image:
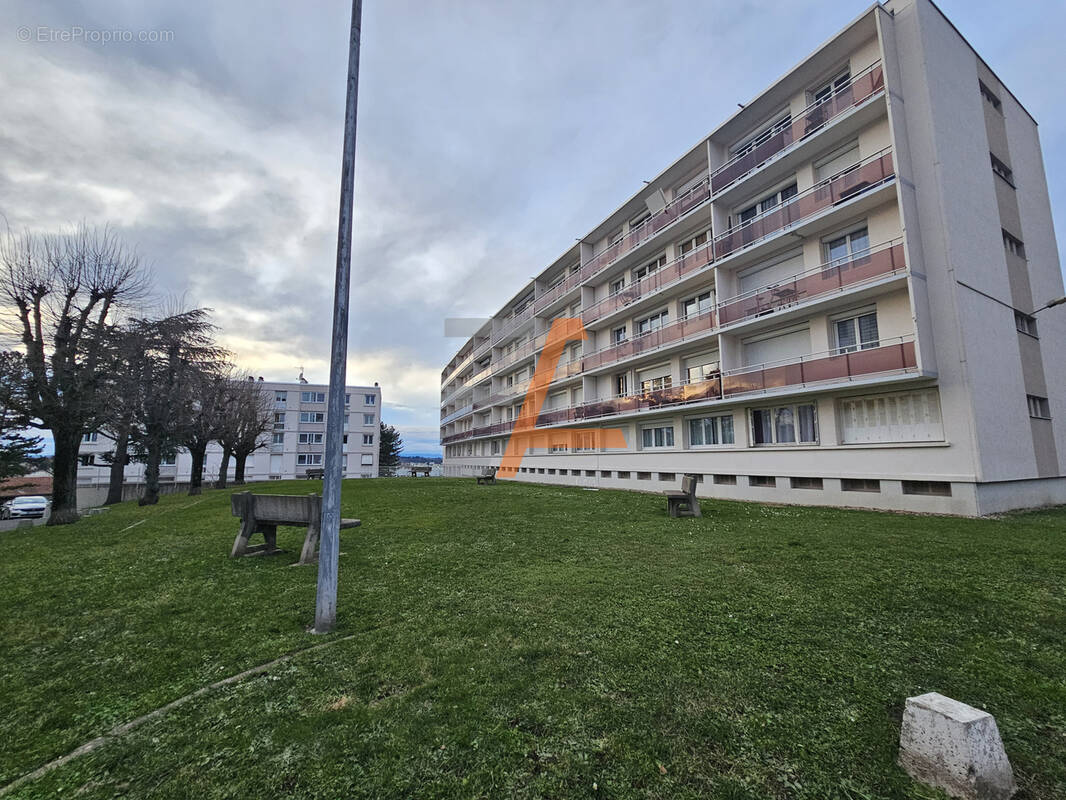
[0,225,148,525]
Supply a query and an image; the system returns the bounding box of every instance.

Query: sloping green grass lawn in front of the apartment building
[0,479,1066,800]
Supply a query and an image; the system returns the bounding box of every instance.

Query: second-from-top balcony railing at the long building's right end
[714,148,894,259]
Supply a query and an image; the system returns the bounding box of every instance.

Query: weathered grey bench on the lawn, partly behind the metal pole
[229,492,361,564]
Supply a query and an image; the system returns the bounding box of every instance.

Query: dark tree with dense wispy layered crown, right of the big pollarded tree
[129,308,228,506]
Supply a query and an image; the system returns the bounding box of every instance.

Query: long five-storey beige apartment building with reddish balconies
[440,0,1066,515]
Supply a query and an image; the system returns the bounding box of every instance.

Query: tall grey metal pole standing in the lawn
[314,0,362,634]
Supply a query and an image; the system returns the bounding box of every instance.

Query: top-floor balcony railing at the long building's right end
[711,62,885,192]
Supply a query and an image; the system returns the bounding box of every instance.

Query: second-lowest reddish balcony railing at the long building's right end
[717,242,906,325]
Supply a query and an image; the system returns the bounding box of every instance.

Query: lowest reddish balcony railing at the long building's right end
[722,336,918,397]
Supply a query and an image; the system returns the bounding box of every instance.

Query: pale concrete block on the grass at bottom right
[900,692,1016,800]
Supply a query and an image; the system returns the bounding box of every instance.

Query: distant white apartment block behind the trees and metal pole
[78,380,382,489]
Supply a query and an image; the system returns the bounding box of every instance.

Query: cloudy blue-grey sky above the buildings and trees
[0,0,1066,453]
